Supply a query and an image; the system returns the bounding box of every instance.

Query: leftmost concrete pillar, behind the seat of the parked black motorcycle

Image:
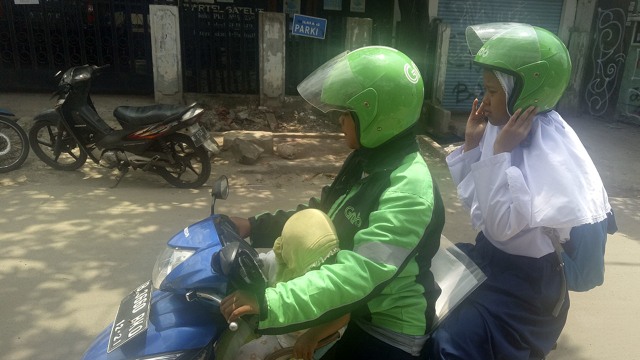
[149,5,183,104]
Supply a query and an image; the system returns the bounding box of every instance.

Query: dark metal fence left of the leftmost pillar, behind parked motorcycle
[0,0,153,93]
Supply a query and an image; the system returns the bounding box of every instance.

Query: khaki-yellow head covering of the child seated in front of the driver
[273,209,340,283]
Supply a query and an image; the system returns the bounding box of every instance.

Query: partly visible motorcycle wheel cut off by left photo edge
[0,116,29,173]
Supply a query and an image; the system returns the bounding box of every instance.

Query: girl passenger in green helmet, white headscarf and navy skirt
[430,24,611,360]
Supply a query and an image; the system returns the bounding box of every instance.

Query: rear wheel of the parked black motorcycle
[155,133,211,189]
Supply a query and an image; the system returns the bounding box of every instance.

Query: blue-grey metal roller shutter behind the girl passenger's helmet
[438,0,564,111]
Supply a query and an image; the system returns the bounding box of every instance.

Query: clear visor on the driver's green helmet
[298,51,362,113]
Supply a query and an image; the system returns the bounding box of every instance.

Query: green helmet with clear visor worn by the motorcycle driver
[298,46,424,148]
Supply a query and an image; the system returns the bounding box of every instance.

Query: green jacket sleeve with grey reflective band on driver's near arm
[258,180,433,334]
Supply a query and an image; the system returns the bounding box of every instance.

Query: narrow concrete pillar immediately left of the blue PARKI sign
[258,12,286,106]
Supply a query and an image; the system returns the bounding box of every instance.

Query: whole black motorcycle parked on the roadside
[29,65,219,188]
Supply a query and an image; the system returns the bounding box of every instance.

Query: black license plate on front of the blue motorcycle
[107,281,151,352]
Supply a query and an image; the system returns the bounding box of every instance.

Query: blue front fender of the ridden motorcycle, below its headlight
[82,291,227,360]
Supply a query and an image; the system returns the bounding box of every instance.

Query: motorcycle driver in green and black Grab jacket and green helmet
[221,46,444,359]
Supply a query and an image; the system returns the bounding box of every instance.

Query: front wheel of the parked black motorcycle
[29,119,87,171]
